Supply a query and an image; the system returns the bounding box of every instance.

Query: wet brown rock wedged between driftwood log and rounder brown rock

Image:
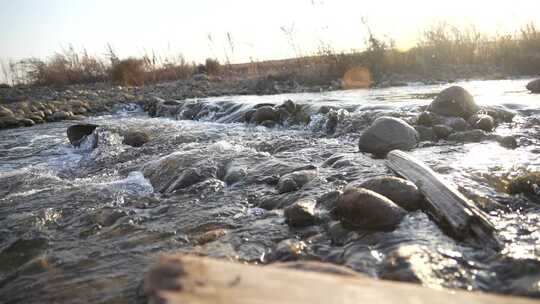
[359,176,423,211]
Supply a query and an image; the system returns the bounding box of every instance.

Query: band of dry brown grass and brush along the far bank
[0,23,540,86]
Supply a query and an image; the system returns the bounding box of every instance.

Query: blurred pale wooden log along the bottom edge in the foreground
[145,254,538,304]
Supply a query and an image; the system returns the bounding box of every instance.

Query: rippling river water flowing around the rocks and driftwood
[0,80,540,303]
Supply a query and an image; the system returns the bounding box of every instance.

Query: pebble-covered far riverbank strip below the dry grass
[0,68,536,129]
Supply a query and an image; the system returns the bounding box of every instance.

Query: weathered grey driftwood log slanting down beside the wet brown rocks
[386,150,502,250]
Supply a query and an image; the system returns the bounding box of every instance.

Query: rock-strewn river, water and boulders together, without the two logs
[0,80,540,303]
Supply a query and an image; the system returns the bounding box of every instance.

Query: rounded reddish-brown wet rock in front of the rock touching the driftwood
[337,187,406,230]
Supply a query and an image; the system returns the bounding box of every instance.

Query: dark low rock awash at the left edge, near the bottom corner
[0,238,48,273]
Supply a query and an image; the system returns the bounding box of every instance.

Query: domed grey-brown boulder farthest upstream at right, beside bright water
[428,86,479,119]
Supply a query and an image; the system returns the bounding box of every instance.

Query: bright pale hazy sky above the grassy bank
[0,0,540,62]
